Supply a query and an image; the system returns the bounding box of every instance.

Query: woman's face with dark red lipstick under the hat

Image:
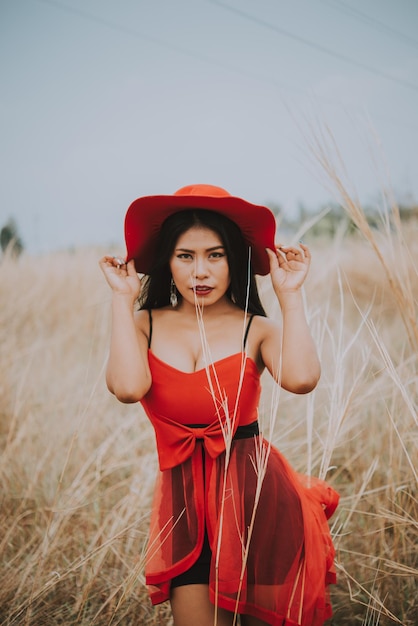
[170,226,230,306]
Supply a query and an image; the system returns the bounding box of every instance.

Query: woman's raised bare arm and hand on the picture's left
[99,256,151,402]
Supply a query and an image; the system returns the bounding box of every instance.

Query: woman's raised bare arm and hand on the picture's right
[260,244,321,393]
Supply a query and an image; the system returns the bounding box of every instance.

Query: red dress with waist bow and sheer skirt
[142,350,338,626]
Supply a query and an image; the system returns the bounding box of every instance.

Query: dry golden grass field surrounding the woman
[0,197,418,626]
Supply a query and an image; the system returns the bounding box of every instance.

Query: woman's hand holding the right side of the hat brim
[267,243,311,295]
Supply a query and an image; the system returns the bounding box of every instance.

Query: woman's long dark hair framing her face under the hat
[139,209,266,316]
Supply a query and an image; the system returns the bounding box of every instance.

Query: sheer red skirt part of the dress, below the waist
[146,437,338,626]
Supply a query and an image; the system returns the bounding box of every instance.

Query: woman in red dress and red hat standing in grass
[100,185,338,626]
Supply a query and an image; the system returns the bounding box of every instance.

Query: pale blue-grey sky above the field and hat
[0,0,418,252]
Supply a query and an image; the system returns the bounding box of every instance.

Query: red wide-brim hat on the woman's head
[125,185,276,276]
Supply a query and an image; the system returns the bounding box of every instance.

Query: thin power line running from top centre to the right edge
[208,0,418,91]
